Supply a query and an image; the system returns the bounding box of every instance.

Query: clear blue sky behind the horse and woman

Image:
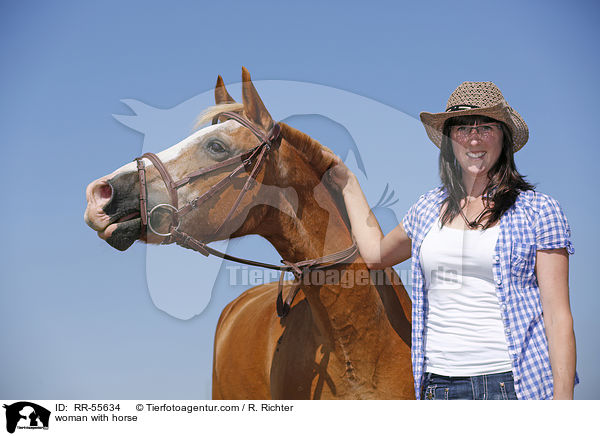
[0,1,600,399]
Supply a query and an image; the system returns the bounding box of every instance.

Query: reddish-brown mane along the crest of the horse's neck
[279,122,350,229]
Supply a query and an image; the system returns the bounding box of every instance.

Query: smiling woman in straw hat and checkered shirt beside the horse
[330,82,576,399]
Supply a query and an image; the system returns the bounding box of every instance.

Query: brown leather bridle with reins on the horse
[135,112,358,317]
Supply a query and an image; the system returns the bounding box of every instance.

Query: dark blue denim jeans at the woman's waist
[421,371,517,400]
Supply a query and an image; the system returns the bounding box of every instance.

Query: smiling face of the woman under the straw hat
[450,121,504,179]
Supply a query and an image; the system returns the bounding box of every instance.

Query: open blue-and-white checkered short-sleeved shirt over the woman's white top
[402,187,577,399]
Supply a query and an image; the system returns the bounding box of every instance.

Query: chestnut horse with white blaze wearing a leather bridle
[85,67,415,400]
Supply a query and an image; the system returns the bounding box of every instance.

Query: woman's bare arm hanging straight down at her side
[536,248,576,400]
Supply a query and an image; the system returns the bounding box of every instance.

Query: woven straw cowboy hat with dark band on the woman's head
[420,82,529,152]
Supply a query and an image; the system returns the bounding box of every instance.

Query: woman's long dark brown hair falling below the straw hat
[439,115,534,229]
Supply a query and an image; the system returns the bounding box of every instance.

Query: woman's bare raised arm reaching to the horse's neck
[329,156,411,269]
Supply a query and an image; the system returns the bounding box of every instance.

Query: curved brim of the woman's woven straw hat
[419,103,529,153]
